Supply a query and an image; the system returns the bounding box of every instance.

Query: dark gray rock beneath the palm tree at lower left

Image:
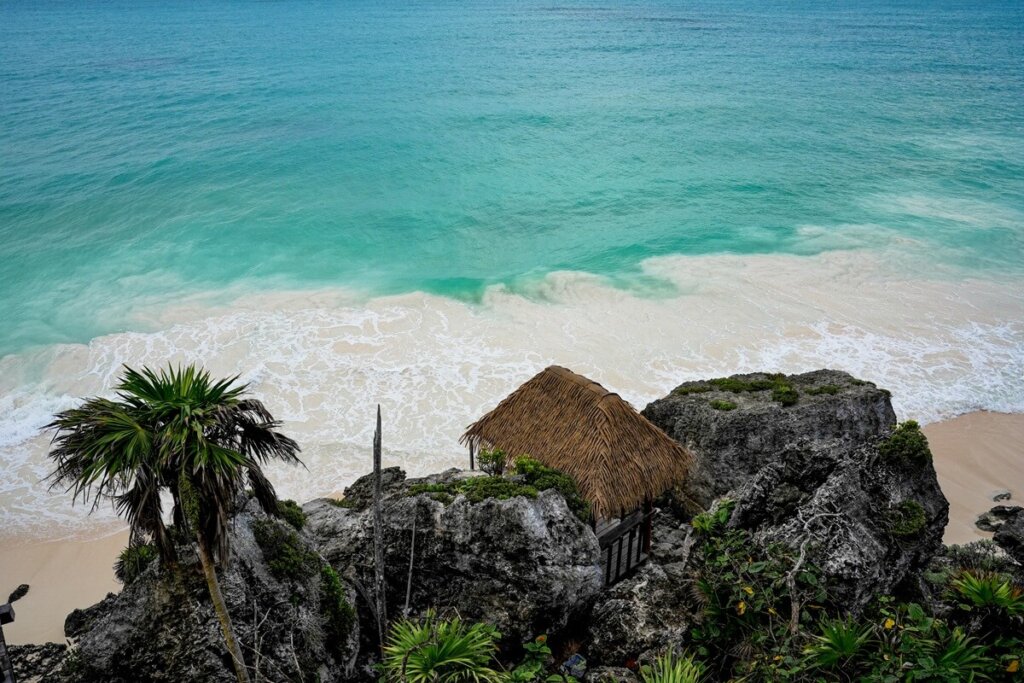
[57,503,357,683]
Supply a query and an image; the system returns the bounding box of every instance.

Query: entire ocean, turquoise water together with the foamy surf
[0,0,1024,538]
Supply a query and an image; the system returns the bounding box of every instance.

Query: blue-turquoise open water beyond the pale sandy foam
[0,0,1024,354]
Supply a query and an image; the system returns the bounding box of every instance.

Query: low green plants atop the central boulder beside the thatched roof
[408,456,590,521]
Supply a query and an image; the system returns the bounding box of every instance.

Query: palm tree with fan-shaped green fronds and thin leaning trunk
[48,366,301,683]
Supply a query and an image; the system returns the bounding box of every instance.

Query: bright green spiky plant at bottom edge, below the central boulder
[381,610,504,683]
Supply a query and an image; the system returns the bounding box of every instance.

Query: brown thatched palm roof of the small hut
[460,366,693,519]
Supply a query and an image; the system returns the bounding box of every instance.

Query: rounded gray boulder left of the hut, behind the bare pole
[304,470,602,642]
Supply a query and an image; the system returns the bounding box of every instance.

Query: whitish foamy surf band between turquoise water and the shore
[0,252,1024,538]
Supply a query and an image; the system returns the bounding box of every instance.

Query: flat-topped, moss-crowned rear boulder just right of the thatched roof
[643,370,896,508]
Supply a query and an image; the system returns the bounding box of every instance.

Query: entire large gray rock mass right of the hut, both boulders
[644,371,949,611]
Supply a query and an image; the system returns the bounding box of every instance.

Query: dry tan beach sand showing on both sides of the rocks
[0,413,1024,644]
